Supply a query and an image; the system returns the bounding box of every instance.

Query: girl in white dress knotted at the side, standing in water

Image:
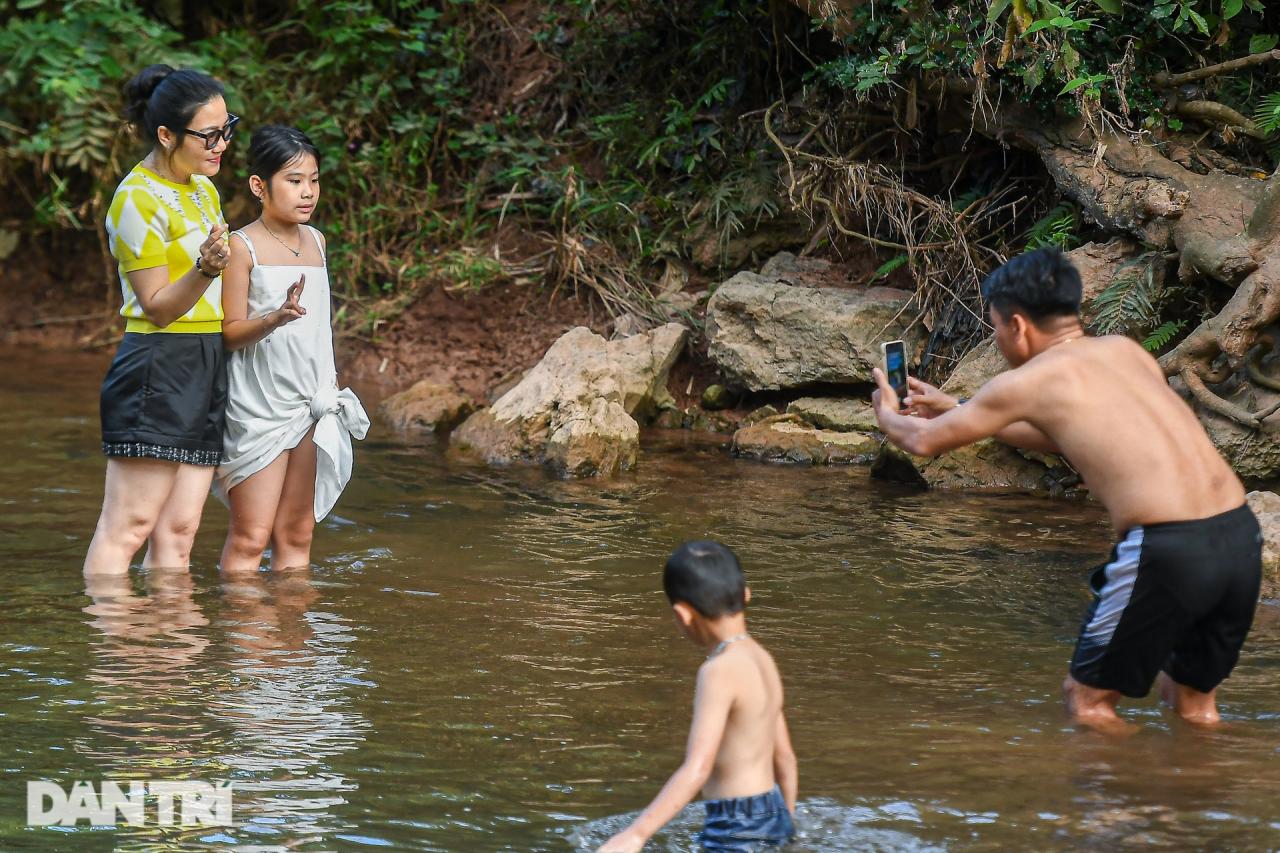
[215,126,369,571]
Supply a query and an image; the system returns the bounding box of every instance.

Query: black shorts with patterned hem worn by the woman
[99,332,227,465]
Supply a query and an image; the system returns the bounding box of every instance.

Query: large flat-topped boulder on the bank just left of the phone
[707,272,923,391]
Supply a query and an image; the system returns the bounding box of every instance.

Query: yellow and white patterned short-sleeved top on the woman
[106,163,223,334]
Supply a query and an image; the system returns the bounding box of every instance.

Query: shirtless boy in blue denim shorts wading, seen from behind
[599,542,797,853]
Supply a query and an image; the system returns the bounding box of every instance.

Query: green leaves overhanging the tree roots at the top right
[817,0,1280,147]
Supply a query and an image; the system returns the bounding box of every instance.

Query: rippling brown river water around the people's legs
[0,348,1280,852]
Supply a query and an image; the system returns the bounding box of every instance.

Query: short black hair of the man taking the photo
[982,248,1083,324]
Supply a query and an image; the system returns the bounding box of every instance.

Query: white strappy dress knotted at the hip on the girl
[214,225,369,521]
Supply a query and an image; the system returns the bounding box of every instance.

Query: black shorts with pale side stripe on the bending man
[1071,505,1262,697]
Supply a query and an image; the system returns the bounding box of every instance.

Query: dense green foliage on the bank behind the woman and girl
[0,0,799,315]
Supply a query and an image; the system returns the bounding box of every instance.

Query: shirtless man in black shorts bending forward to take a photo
[872,250,1262,726]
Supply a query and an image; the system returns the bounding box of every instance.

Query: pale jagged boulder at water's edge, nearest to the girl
[452,323,687,476]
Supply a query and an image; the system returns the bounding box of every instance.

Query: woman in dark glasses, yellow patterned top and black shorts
[84,65,239,574]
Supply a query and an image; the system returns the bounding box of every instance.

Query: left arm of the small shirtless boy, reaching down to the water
[598,662,733,853]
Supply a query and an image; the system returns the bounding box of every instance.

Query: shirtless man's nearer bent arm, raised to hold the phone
[872,368,1029,456]
